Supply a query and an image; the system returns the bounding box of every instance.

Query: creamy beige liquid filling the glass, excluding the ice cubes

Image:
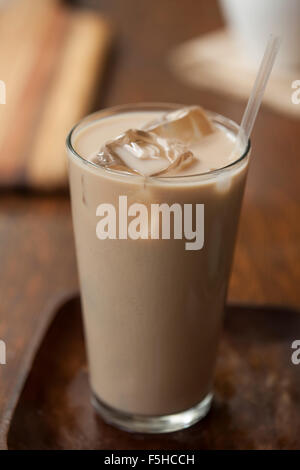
[69,106,248,415]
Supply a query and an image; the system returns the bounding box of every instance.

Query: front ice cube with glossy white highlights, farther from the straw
[96,129,194,176]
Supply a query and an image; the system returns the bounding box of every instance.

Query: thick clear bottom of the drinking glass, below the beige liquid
[92,393,213,433]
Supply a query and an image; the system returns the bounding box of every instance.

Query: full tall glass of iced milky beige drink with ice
[67,105,249,432]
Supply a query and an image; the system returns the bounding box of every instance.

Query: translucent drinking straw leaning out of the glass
[237,35,281,151]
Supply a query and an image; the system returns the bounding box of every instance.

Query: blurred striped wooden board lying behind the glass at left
[0,0,111,189]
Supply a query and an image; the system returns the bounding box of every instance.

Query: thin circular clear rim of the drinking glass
[66,102,251,183]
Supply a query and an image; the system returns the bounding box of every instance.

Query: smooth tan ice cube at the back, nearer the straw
[144,106,214,145]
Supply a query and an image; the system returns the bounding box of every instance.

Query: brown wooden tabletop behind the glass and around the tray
[0,0,300,447]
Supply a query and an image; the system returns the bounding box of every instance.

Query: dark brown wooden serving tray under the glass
[7,298,300,450]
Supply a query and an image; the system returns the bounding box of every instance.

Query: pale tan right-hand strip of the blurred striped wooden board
[26,10,111,189]
